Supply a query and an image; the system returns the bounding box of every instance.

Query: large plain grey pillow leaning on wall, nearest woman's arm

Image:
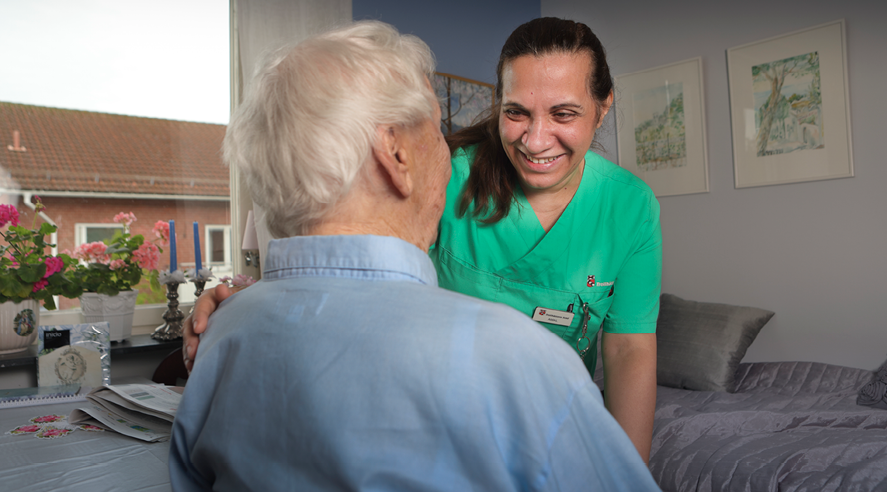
[656,294,773,393]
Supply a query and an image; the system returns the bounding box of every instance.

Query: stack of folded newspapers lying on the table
[68,384,182,442]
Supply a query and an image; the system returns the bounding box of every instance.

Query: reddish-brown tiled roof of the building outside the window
[0,102,230,197]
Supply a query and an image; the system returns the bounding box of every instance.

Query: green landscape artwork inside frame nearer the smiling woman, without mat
[632,82,687,172]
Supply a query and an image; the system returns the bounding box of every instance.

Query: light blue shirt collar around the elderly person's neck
[264,235,437,287]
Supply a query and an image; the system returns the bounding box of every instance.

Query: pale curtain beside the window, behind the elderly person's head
[231,0,352,278]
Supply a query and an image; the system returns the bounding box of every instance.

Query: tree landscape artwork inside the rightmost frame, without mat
[751,51,825,157]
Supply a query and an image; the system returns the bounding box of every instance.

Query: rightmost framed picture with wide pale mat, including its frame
[727,19,853,188]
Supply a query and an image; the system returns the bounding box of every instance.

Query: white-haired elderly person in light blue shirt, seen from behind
[169,22,658,491]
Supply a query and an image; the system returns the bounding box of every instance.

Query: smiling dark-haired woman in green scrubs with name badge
[185,18,662,461]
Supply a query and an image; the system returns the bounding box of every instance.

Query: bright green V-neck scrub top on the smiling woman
[430,147,662,376]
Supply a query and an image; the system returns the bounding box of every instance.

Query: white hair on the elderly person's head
[223,21,435,238]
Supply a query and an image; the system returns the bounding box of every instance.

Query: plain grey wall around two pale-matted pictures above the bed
[542,0,887,369]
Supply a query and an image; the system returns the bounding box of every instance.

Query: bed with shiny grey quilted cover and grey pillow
[650,294,887,492]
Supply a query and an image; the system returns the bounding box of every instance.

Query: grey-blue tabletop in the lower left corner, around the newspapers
[0,392,172,492]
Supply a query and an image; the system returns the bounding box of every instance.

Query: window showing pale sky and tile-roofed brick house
[0,0,231,326]
